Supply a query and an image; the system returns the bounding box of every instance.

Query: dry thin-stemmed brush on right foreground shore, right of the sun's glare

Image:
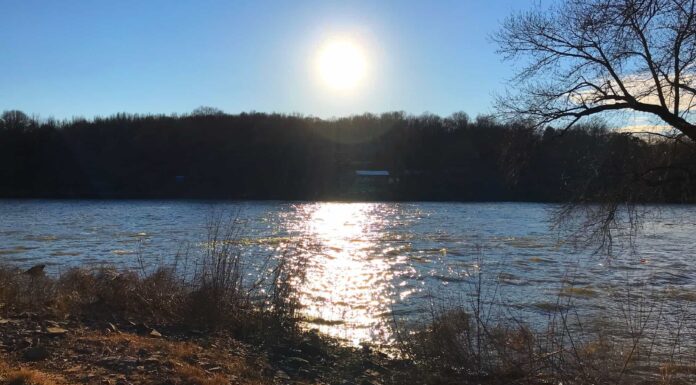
[395,252,696,385]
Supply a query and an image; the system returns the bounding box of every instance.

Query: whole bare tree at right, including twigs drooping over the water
[493,0,696,251]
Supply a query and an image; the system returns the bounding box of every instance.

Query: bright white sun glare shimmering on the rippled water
[299,203,399,345]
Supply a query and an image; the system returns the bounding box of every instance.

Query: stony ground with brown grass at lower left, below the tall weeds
[0,312,406,385]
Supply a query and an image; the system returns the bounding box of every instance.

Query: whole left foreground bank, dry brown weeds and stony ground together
[0,256,412,385]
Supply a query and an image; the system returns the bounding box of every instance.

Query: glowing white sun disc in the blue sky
[317,39,367,90]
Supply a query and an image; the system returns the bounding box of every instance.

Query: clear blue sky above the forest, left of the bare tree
[0,0,533,118]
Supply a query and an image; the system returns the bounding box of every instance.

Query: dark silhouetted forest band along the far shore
[0,108,696,202]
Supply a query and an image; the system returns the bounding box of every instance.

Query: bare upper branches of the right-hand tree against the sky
[494,0,696,140]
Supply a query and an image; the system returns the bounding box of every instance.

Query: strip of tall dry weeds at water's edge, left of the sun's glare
[0,218,300,342]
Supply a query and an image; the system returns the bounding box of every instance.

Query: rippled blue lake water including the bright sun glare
[0,200,696,344]
